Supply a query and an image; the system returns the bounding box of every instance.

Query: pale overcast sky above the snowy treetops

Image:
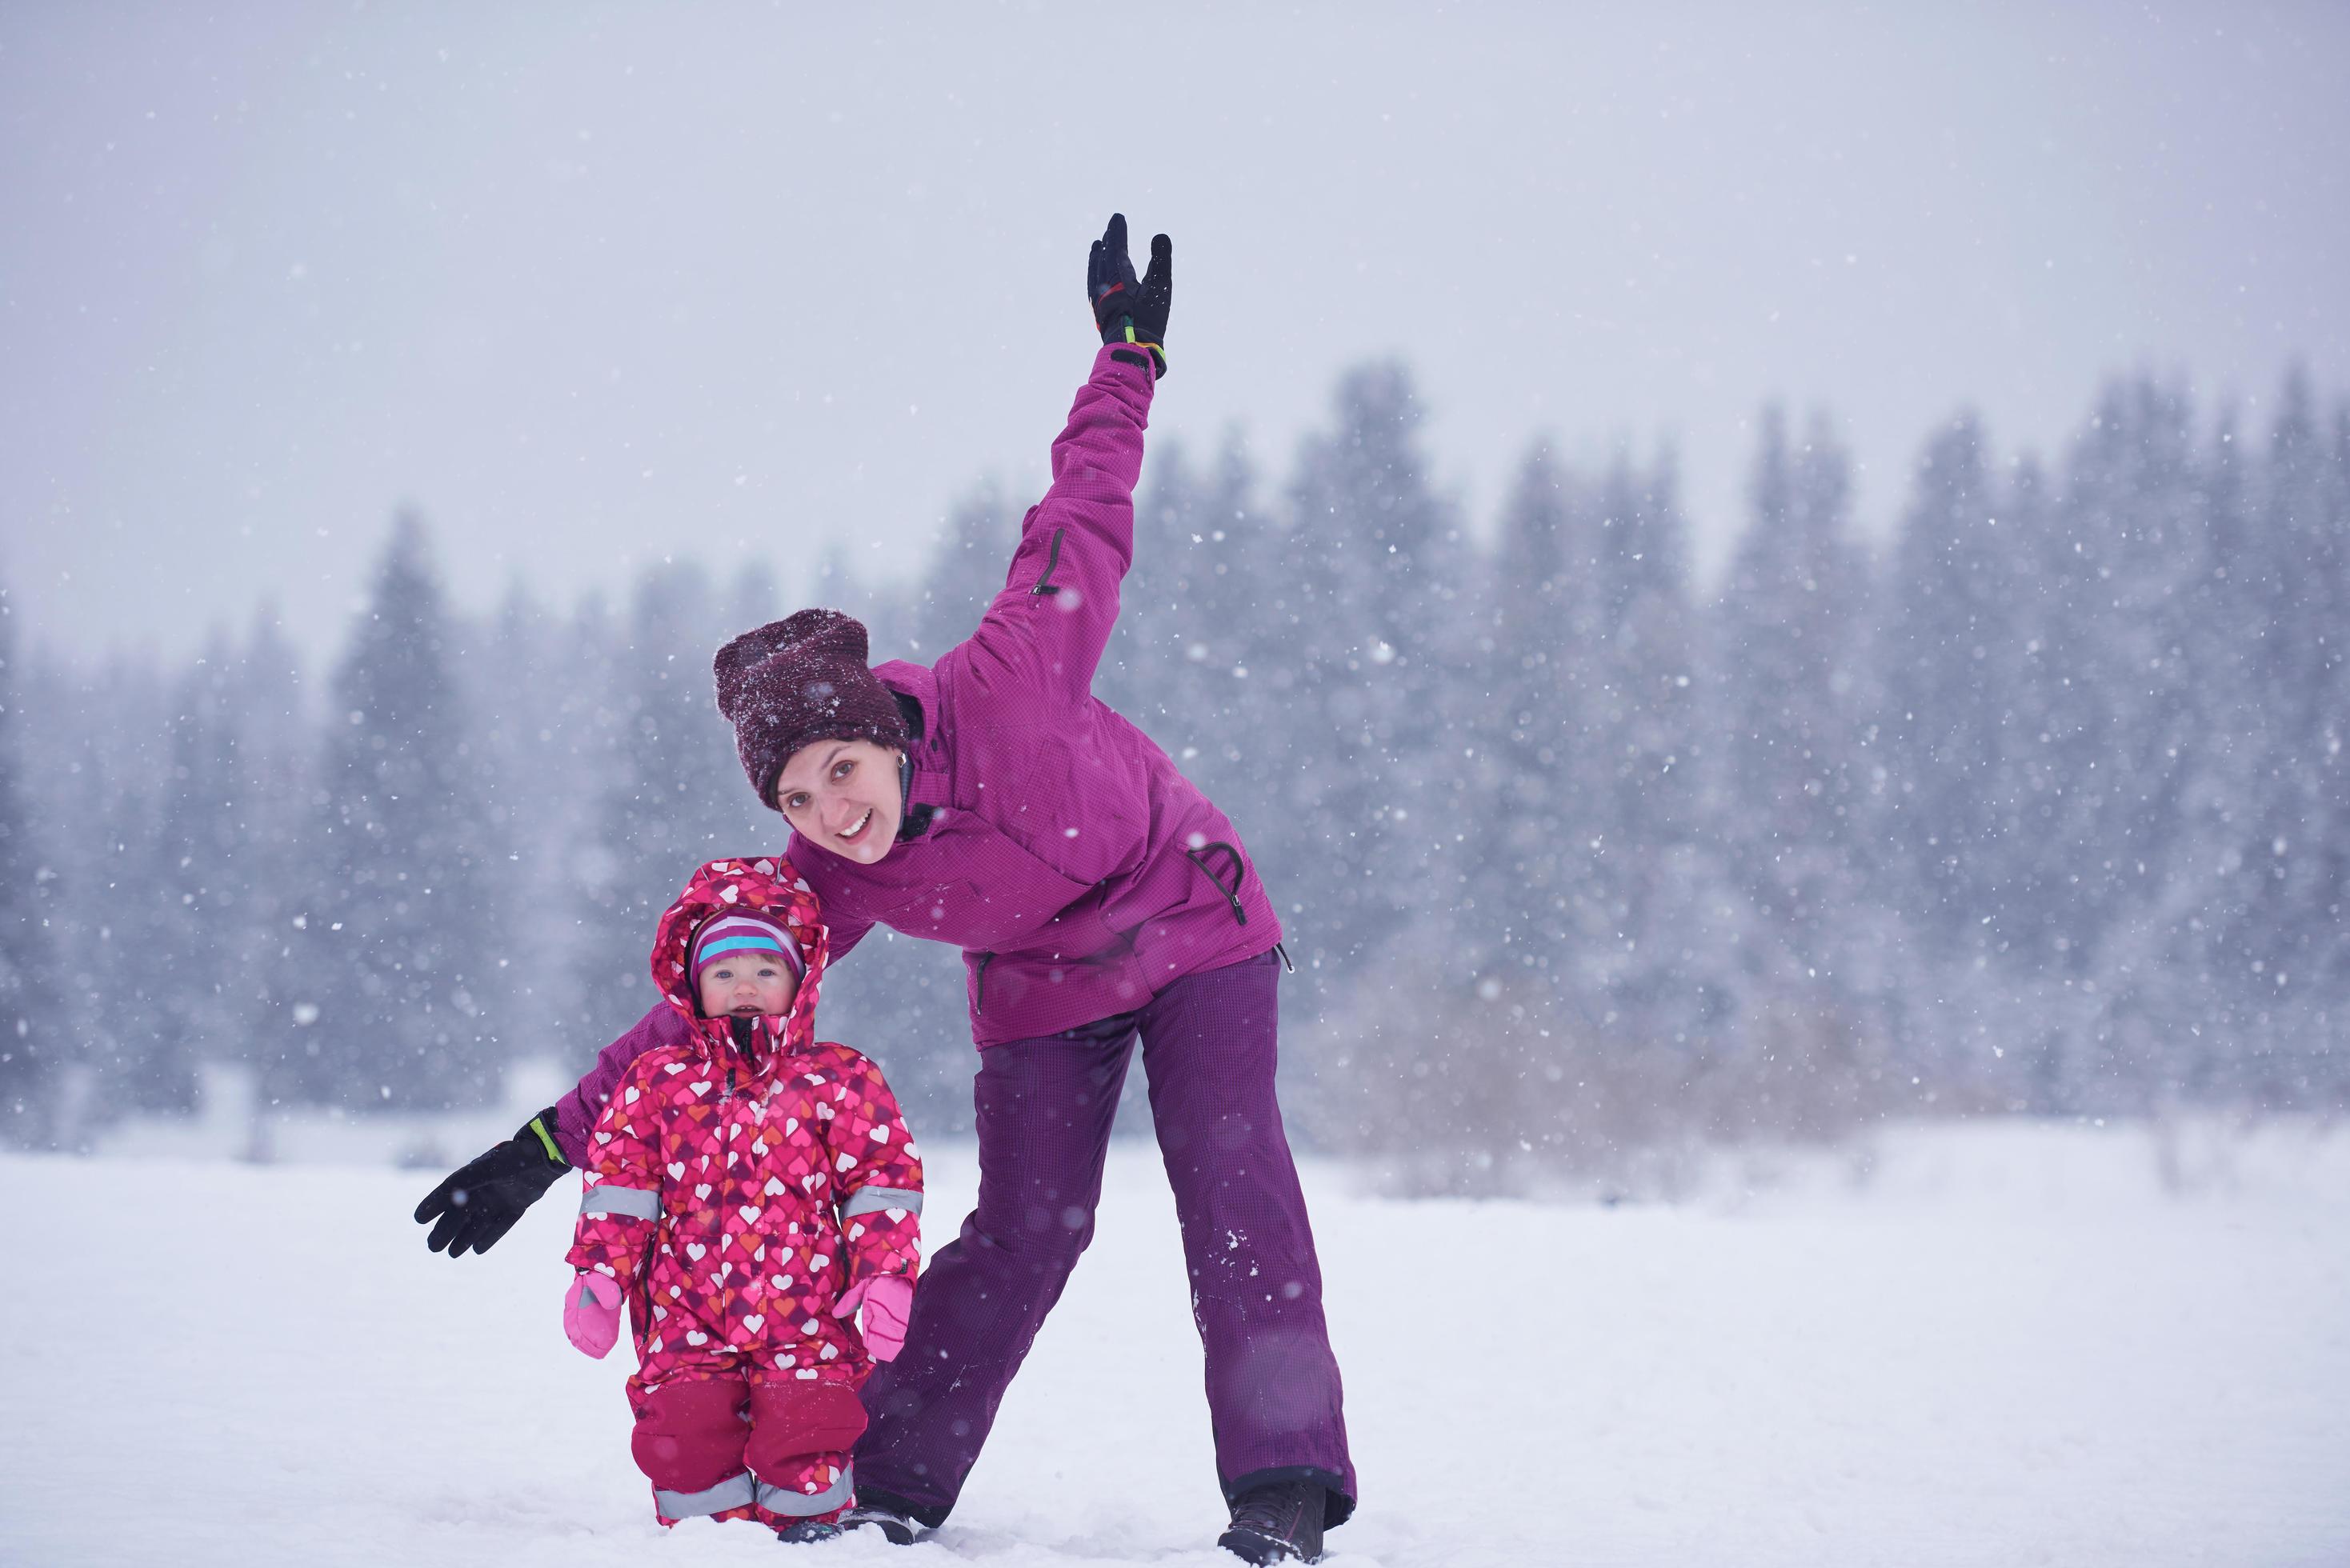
[0,0,2350,654]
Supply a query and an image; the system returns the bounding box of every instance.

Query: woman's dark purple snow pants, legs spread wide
[855,952,1354,1526]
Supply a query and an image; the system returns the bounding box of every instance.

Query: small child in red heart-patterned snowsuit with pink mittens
[564,856,921,1540]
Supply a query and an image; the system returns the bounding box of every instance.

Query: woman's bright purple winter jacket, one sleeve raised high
[554,346,1281,1164]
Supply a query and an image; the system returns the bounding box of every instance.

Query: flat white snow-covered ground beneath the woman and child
[0,1126,2350,1568]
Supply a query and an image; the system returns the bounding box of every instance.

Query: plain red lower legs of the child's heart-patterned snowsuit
[627,1352,865,1526]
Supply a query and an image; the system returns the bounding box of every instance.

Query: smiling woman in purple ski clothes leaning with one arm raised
[418,216,1356,1563]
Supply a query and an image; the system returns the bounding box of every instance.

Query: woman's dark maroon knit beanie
[712,609,910,809]
